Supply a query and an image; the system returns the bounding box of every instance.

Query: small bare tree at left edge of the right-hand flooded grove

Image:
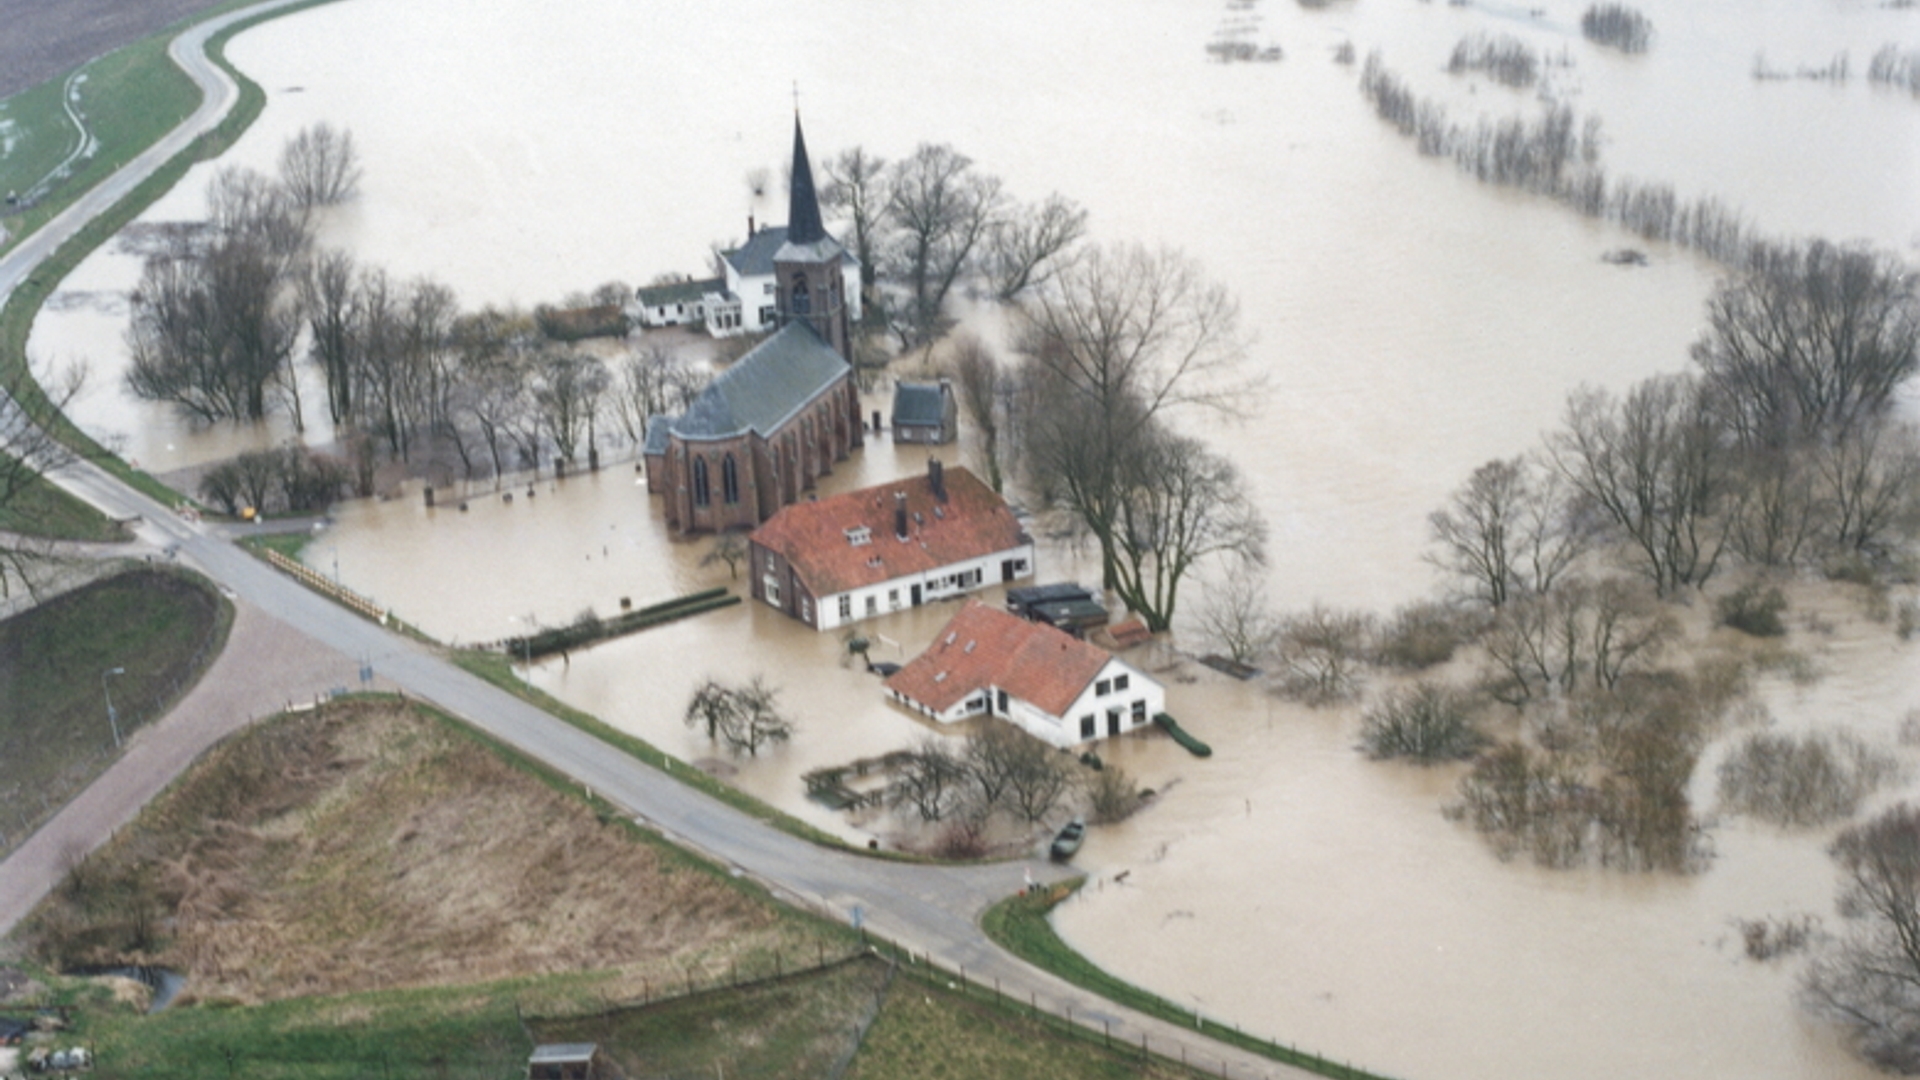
[1427,457,1584,607]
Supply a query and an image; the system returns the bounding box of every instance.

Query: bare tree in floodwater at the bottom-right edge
[1803,803,1920,1072]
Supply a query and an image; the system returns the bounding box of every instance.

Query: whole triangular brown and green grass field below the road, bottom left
[7,698,1228,1080]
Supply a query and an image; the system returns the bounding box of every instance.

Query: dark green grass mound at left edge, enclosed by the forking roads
[0,569,232,851]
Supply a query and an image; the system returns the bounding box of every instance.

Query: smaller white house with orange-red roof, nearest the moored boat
[887,600,1167,746]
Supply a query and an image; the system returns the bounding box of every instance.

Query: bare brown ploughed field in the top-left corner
[0,0,221,98]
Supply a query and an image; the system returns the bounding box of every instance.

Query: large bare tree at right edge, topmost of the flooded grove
[1693,242,1920,448]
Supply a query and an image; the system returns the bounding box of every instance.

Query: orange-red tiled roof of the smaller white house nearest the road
[887,600,1114,717]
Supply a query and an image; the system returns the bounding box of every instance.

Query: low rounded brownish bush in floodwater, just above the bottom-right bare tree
[1718,732,1899,828]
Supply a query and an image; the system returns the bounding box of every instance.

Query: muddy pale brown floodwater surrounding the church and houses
[22,0,1920,1080]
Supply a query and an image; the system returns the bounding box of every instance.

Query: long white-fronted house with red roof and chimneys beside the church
[749,461,1033,630]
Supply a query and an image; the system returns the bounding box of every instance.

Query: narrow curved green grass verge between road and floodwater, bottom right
[981,882,1384,1080]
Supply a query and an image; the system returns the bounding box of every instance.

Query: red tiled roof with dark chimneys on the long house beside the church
[753,467,1031,598]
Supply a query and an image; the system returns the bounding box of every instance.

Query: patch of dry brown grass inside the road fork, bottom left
[31,701,812,1001]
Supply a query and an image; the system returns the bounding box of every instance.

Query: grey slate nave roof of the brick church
[668,319,852,441]
